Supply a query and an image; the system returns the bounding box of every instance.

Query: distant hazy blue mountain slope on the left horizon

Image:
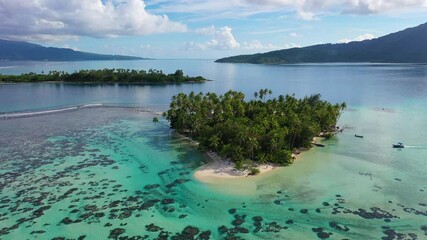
[0,39,144,61]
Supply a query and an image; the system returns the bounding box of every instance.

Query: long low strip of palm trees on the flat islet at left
[0,69,206,83]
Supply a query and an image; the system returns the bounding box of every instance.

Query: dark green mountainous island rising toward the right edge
[216,23,427,64]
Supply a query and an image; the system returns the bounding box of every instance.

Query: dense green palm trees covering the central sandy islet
[164,89,346,168]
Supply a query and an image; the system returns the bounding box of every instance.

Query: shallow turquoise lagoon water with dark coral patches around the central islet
[0,108,427,239]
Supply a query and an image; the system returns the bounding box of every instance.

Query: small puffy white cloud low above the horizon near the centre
[185,26,240,50]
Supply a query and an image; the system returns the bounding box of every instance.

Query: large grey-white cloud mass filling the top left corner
[0,0,186,39]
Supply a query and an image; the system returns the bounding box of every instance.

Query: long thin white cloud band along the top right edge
[151,0,427,20]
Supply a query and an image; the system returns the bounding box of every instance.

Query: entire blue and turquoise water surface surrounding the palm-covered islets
[0,60,427,239]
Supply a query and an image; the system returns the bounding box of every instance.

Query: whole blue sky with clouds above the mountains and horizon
[0,0,427,59]
